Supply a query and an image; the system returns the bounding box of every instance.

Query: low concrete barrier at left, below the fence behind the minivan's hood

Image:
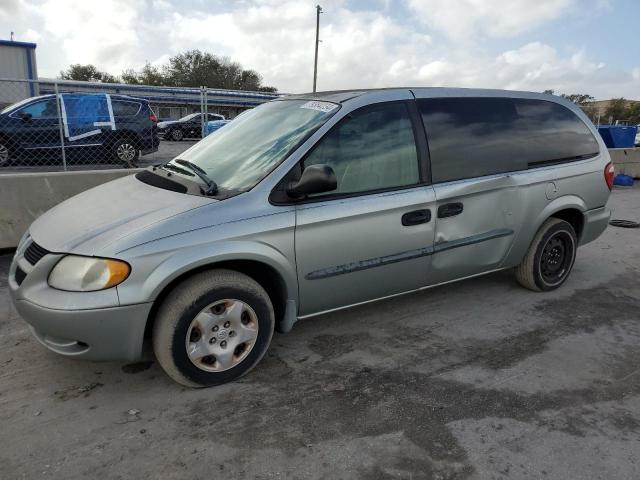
[0,169,139,248]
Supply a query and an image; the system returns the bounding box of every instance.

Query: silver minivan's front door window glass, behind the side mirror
[303,103,420,196]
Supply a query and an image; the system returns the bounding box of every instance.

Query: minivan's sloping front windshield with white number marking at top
[170,100,339,191]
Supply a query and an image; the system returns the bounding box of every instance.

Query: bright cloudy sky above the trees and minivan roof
[0,0,640,99]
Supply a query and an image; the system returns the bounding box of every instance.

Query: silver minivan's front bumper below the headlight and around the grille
[7,237,152,361]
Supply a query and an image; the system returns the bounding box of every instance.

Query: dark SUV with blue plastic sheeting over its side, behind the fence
[0,93,160,167]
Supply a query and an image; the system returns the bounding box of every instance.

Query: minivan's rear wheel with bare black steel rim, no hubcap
[515,217,578,292]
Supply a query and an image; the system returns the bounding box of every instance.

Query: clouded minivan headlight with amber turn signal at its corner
[49,255,131,292]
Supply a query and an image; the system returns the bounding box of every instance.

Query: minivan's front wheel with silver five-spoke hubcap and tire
[152,269,275,387]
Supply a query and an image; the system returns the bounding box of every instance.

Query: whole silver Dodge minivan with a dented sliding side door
[9,88,613,387]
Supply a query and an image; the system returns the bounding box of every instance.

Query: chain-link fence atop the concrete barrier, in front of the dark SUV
[0,79,275,174]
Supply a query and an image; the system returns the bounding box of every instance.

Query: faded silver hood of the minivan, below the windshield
[29,175,212,255]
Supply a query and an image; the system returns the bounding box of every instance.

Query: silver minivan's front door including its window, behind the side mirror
[295,102,435,316]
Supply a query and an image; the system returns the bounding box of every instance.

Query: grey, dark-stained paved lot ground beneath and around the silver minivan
[0,189,640,480]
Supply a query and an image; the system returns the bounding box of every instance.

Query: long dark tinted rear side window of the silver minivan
[418,98,599,182]
